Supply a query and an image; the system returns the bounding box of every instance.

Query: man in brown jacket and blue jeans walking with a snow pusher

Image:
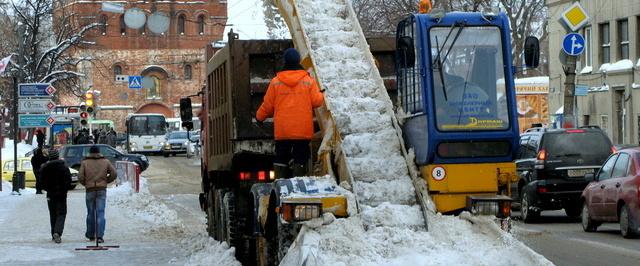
[78,145,117,243]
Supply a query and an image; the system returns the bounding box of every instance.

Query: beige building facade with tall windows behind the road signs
[547,0,640,144]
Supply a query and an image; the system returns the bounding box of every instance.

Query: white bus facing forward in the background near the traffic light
[127,114,167,153]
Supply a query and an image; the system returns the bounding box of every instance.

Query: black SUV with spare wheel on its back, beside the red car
[513,128,615,222]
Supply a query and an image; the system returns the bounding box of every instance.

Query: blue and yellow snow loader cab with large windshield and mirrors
[396,12,539,218]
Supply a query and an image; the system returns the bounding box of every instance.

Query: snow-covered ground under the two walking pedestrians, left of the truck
[0,157,239,265]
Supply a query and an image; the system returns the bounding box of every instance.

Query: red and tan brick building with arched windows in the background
[62,0,227,131]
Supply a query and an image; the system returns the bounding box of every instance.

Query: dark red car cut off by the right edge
[581,148,640,238]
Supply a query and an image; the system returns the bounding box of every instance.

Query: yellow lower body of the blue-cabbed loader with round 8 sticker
[420,162,517,213]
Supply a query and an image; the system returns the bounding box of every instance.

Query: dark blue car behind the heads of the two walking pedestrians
[60,144,149,171]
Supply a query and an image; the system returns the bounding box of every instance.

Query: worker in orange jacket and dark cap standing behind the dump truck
[256,48,324,178]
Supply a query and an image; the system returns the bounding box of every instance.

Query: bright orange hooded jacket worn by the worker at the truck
[256,70,324,140]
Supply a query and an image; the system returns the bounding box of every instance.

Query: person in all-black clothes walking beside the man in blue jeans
[40,149,71,244]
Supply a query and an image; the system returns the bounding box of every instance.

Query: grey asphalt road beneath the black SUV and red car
[514,210,640,266]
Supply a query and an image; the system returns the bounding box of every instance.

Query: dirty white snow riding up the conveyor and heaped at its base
[283,0,551,265]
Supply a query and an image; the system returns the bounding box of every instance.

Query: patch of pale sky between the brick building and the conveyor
[224,0,268,40]
